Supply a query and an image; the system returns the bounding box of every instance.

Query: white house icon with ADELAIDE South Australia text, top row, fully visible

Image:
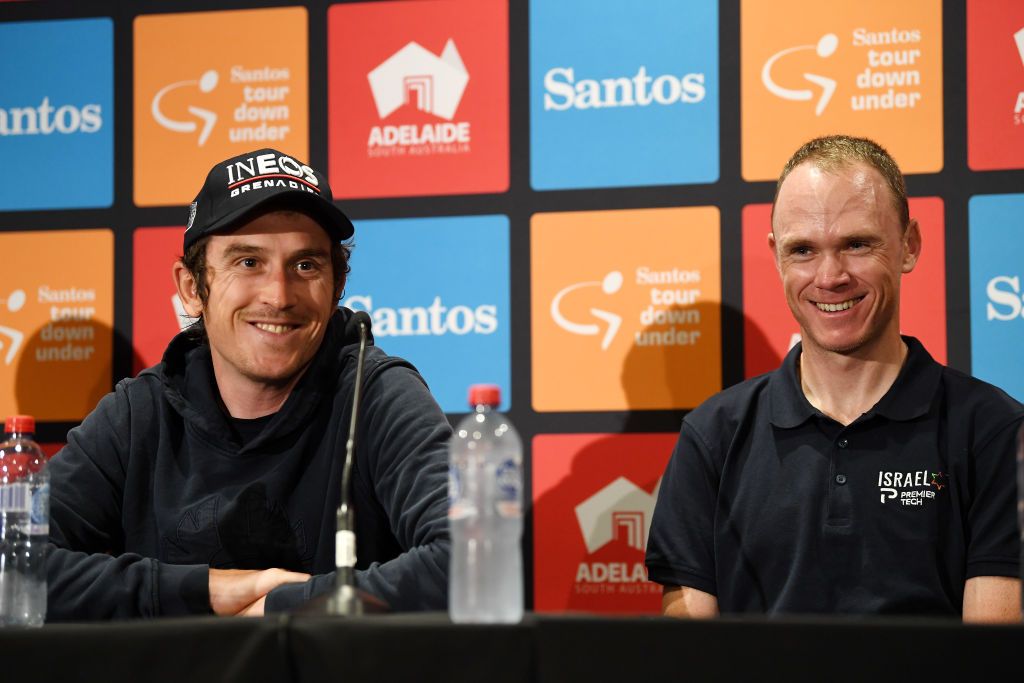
[367,39,470,157]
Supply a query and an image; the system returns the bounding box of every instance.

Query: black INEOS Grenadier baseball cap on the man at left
[184,148,355,250]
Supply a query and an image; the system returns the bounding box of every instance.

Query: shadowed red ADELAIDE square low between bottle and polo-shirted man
[532,434,676,614]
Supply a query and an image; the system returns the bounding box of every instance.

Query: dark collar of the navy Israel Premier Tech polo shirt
[770,336,942,429]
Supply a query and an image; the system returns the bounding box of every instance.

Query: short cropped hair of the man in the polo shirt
[771,135,910,230]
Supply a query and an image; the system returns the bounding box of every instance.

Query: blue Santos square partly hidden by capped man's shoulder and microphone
[341,216,511,413]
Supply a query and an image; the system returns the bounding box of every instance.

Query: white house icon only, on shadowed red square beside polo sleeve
[575,477,662,554]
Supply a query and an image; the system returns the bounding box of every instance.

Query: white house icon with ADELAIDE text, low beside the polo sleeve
[575,477,662,584]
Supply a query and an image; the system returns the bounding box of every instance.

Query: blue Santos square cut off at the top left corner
[0,18,114,211]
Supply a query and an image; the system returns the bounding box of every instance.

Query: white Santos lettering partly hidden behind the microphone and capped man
[342,295,498,337]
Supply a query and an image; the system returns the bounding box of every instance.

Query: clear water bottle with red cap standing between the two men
[449,384,522,624]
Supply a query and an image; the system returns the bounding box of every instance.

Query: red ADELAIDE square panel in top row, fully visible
[328,0,509,198]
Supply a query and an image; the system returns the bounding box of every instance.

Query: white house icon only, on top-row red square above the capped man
[367,39,469,121]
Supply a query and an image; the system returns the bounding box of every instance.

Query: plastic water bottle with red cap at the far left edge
[0,415,50,626]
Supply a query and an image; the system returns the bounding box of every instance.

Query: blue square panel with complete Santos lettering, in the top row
[529,0,719,189]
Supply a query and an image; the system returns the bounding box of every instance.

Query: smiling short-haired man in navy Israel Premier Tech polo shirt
[647,136,1024,621]
